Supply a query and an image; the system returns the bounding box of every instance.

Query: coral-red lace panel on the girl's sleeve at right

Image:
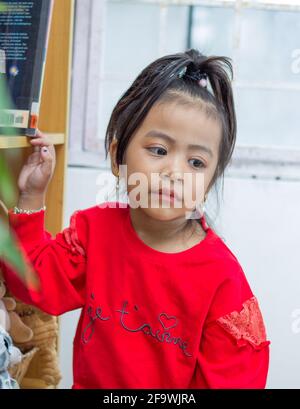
[217,296,270,349]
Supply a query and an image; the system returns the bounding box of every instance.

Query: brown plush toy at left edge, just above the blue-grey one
[0,280,33,343]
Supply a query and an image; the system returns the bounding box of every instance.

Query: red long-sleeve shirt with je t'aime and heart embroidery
[4,202,269,388]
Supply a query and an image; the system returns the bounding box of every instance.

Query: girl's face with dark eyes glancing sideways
[111,102,222,220]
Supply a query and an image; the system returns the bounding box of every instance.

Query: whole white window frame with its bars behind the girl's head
[69,0,300,180]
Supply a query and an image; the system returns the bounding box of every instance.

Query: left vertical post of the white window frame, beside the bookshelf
[68,0,107,168]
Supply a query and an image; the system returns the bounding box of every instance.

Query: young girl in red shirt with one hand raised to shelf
[4,49,270,388]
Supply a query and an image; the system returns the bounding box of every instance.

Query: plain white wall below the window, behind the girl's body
[60,168,300,388]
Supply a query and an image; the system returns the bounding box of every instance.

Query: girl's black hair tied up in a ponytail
[105,49,236,230]
